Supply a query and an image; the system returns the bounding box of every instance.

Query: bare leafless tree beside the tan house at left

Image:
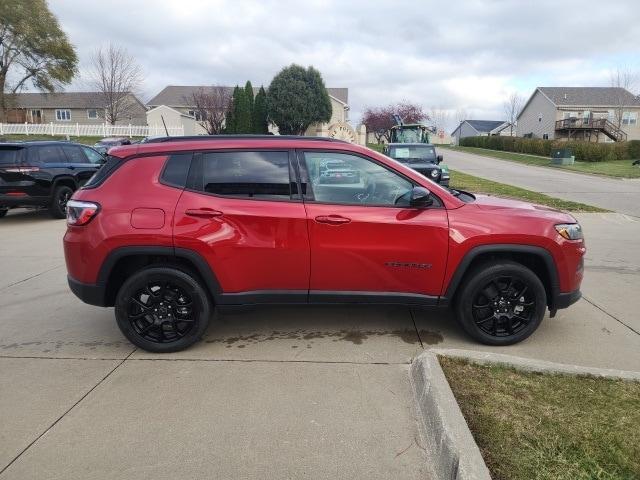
[89,44,144,125]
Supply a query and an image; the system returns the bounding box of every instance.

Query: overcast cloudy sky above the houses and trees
[49,0,640,129]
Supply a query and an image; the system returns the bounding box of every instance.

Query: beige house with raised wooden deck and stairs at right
[517,87,640,142]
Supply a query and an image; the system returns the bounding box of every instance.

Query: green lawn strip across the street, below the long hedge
[445,146,640,178]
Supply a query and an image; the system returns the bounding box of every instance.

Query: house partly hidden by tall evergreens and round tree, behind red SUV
[147,85,349,135]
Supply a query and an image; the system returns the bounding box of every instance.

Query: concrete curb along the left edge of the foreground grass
[410,351,491,480]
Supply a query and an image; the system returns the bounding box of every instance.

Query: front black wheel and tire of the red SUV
[455,260,547,345]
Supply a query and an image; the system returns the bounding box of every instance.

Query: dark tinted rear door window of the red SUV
[200,151,296,200]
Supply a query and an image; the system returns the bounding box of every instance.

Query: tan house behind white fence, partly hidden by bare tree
[7,92,147,125]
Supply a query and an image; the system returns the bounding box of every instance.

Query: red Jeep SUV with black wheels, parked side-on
[64,136,585,352]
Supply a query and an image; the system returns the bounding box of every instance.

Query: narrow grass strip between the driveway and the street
[450,170,608,212]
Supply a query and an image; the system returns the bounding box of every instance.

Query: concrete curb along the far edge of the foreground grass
[429,348,640,380]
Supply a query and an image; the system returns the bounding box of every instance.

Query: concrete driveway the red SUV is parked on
[0,208,640,480]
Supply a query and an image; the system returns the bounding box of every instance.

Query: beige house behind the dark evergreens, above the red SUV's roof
[147,85,364,143]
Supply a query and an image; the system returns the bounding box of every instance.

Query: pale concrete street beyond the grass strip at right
[438,148,640,218]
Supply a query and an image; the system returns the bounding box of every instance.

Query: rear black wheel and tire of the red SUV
[115,267,212,353]
